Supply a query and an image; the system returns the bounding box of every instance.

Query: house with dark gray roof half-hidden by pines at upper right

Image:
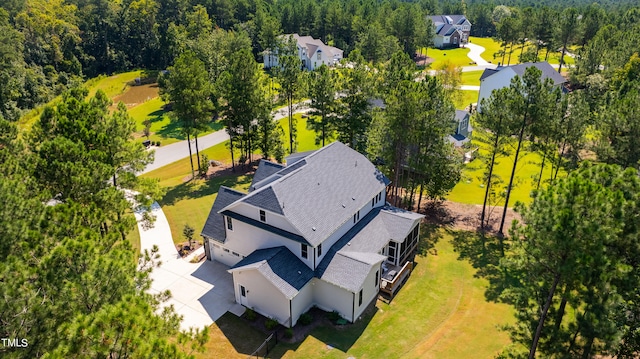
[477,62,567,112]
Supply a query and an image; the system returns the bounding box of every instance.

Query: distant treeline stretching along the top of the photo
[0,0,628,120]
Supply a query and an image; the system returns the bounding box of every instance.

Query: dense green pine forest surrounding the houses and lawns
[0,0,640,358]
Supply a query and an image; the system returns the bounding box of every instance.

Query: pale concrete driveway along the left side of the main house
[136,202,244,330]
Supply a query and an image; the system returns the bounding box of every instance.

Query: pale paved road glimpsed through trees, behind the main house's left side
[140,101,309,174]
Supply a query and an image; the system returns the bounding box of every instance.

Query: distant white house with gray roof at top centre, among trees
[264,34,343,71]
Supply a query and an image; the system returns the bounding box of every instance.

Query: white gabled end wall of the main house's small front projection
[233,270,289,326]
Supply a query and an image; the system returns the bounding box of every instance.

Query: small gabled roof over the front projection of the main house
[229,247,313,299]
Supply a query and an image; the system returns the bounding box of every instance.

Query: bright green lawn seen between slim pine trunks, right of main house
[447,129,551,206]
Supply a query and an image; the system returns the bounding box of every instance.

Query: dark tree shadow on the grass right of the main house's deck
[450,231,514,302]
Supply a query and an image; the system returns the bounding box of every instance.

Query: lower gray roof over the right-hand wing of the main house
[316,206,424,292]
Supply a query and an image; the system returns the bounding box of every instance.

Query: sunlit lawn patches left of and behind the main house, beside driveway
[143,114,320,243]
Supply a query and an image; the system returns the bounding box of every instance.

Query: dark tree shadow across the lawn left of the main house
[160,175,252,206]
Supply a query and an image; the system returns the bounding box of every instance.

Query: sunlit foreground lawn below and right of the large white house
[200,230,513,359]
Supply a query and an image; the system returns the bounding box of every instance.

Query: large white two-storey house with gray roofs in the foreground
[202,142,424,327]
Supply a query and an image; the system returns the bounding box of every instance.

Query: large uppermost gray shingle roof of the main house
[224,142,390,246]
